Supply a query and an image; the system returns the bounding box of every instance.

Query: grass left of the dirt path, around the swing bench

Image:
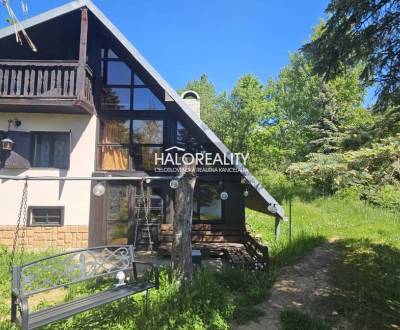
[0,235,317,330]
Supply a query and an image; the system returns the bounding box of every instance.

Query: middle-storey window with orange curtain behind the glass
[99,119,164,171]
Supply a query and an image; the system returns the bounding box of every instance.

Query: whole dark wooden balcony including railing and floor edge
[0,60,94,114]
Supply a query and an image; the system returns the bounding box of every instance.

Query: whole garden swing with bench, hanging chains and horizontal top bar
[4,175,171,330]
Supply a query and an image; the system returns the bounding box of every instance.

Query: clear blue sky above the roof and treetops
[0,0,328,91]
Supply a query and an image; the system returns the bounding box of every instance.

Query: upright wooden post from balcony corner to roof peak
[76,8,88,99]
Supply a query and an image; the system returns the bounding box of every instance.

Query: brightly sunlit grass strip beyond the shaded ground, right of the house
[247,197,400,248]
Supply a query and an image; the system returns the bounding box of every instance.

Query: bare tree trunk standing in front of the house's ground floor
[171,157,196,283]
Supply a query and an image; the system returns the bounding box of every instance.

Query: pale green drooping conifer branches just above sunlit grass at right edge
[287,134,400,205]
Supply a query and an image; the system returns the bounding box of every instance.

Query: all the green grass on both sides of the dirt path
[0,198,400,330]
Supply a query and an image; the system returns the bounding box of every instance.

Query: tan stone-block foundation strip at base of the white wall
[0,226,89,250]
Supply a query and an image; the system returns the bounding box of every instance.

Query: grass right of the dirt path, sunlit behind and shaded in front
[248,198,400,329]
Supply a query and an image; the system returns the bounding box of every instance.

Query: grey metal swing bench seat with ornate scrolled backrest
[11,245,159,330]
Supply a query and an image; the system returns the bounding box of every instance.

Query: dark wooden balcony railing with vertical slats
[0,60,93,113]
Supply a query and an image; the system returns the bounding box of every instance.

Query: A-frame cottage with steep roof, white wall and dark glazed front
[0,0,284,253]
